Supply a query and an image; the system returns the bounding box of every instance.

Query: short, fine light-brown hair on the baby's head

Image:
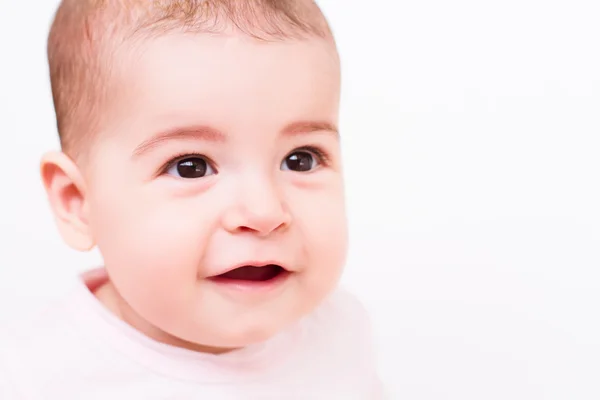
[48,0,333,158]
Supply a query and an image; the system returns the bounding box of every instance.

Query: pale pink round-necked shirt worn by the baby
[0,272,383,400]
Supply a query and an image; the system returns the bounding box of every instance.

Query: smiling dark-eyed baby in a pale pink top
[0,0,381,400]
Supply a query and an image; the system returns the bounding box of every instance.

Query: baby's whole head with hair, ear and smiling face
[42,0,347,352]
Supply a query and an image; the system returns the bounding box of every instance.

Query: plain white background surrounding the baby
[0,0,600,400]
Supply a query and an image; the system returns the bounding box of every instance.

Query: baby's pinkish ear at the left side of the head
[40,152,95,251]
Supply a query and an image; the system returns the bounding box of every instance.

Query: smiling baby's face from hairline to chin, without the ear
[86,35,347,348]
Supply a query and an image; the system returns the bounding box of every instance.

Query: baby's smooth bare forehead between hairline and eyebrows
[102,34,340,142]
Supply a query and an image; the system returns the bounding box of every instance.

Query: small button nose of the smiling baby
[223,179,292,236]
